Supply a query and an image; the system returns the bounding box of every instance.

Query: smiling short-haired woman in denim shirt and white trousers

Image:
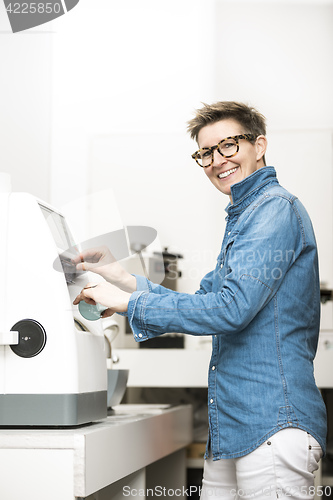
[74,102,326,500]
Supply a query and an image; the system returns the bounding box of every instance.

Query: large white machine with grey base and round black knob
[0,174,107,427]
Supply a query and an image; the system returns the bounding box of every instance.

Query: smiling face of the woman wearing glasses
[198,118,267,202]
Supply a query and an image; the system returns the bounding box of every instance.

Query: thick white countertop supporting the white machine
[0,405,192,500]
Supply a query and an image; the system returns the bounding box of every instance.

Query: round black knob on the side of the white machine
[10,319,46,358]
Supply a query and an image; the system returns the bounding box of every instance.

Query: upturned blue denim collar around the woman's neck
[226,167,278,213]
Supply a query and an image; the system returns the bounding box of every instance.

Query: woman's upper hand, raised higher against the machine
[73,246,136,293]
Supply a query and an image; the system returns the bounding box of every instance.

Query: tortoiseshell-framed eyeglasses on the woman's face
[192,134,256,167]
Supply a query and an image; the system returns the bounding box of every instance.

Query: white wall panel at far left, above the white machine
[0,2,52,199]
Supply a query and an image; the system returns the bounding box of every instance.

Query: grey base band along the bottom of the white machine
[0,391,107,427]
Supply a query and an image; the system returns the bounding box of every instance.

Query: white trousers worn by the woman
[200,428,322,500]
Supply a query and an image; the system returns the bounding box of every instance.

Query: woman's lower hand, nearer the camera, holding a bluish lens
[73,281,131,317]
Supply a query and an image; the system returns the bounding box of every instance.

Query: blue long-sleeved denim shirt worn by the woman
[128,167,326,460]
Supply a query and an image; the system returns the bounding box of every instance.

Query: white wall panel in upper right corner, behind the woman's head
[216,0,333,131]
